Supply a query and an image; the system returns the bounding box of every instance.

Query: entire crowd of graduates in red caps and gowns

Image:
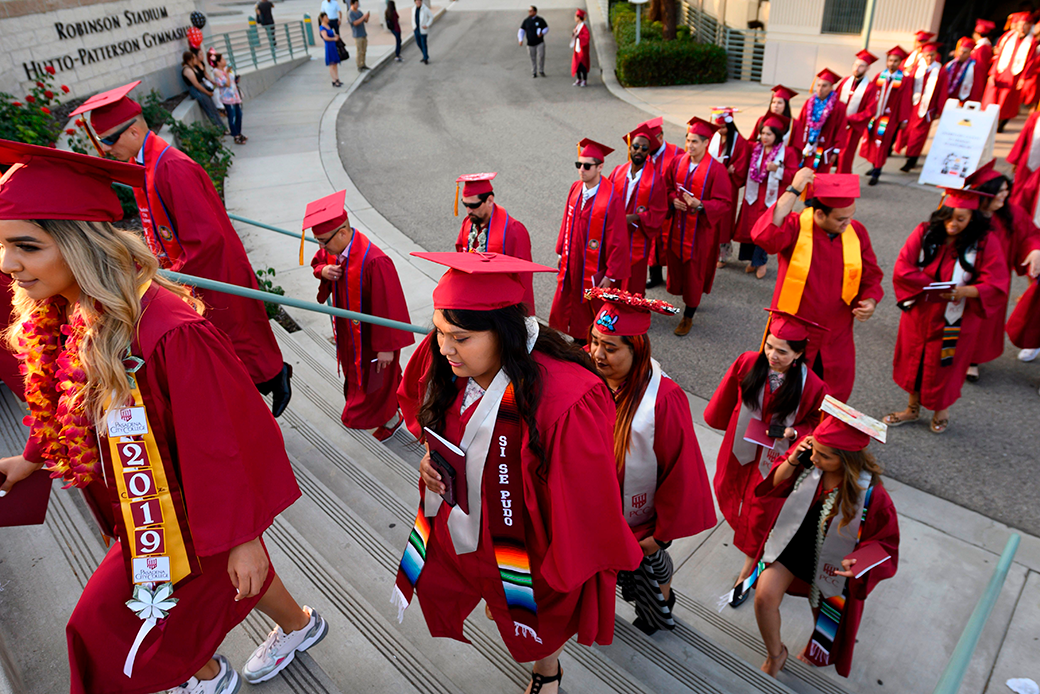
[0,10,1040,694]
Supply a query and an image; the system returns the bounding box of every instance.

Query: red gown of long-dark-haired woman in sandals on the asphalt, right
[892,223,1010,410]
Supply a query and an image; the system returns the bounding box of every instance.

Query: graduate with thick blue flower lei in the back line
[790,68,846,174]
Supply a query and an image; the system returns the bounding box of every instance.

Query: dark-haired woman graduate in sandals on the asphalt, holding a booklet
[884,189,1009,434]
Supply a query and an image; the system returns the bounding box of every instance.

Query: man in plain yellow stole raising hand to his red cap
[751,169,885,400]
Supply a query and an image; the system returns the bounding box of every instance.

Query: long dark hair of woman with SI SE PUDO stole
[419,304,602,479]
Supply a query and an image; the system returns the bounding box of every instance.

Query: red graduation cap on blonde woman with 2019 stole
[0,139,145,222]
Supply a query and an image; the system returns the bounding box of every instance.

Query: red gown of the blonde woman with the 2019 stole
[66,285,300,694]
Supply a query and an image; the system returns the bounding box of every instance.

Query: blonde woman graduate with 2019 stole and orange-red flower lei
[0,140,328,694]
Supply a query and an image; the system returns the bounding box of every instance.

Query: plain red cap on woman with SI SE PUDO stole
[412,252,556,311]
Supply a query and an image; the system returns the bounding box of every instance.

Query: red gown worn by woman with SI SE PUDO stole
[402,352,643,663]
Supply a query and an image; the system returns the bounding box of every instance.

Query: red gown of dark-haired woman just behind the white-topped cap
[704,352,827,557]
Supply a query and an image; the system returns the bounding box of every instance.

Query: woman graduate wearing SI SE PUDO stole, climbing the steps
[393,253,643,694]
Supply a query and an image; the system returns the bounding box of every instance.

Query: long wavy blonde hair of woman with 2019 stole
[4,220,203,432]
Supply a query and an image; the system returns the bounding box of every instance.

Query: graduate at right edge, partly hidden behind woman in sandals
[964,159,1040,381]
